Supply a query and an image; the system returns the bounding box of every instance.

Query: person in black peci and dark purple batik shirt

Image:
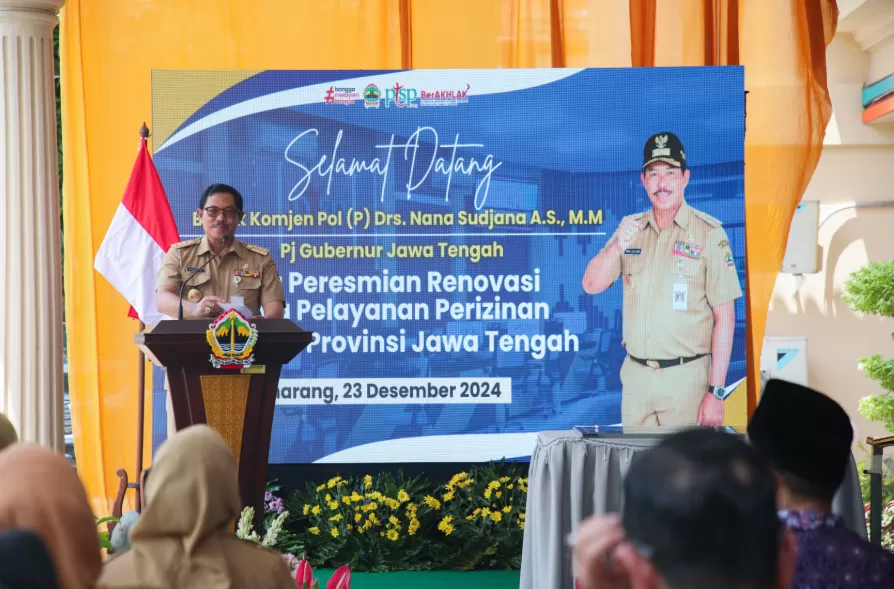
[748,379,894,589]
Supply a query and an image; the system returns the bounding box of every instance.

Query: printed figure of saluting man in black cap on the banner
[583,132,742,431]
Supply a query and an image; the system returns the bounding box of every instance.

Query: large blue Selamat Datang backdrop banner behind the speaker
[153,67,746,463]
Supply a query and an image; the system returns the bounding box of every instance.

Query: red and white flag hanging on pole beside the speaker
[93,139,180,325]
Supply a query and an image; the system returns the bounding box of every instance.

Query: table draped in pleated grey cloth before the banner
[520,430,867,589]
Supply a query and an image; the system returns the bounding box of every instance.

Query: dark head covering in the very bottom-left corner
[0,529,59,589]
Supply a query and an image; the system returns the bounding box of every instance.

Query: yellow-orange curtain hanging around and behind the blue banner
[61,0,838,513]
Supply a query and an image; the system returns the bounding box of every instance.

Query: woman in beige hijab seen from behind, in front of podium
[99,425,295,589]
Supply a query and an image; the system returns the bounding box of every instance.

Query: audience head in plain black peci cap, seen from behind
[748,379,854,510]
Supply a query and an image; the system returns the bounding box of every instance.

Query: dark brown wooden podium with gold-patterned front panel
[136,319,313,534]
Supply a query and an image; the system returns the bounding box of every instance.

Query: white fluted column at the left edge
[0,0,65,451]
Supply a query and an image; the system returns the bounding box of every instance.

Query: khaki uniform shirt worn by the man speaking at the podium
[155,237,286,315]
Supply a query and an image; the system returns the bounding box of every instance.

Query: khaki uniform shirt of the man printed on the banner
[608,202,742,360]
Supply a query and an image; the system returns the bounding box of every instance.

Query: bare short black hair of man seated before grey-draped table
[622,429,782,589]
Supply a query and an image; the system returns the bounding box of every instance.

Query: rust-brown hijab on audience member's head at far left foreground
[0,444,102,589]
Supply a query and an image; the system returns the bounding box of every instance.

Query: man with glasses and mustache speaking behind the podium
[155,184,286,435]
